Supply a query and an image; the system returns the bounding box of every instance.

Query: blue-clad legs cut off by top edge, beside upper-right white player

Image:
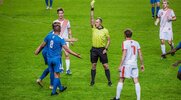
[150,0,160,18]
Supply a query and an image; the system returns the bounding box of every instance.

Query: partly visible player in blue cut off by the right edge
[161,42,181,80]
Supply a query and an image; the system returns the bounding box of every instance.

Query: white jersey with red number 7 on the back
[122,40,140,68]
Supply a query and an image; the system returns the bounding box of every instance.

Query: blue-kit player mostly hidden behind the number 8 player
[36,30,77,89]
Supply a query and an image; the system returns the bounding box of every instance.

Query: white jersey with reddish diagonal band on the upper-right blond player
[158,9,175,32]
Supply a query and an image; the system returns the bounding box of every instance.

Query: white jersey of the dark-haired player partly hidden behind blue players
[53,19,70,39]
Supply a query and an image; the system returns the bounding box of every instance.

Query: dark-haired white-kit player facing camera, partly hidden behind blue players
[54,8,73,75]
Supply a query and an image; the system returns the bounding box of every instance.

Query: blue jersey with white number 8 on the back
[44,34,66,58]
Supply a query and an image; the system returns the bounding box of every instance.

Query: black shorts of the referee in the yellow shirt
[90,47,108,64]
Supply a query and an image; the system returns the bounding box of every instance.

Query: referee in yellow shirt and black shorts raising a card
[90,0,112,86]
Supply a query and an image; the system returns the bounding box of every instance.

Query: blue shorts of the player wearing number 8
[48,57,62,73]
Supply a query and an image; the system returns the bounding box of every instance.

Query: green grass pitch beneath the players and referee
[0,0,181,100]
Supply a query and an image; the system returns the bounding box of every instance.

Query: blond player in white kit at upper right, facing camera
[155,0,176,58]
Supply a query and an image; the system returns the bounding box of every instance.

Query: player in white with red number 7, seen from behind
[113,29,144,100]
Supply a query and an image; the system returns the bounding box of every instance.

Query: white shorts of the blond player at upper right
[160,29,173,41]
